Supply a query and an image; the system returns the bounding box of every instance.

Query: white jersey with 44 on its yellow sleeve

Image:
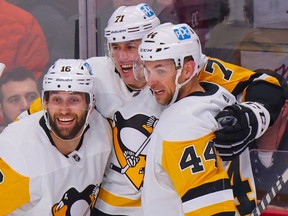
[142,83,235,216]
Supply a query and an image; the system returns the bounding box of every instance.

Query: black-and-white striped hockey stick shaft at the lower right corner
[250,168,288,216]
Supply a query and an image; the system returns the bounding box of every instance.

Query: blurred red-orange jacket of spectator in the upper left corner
[0,0,49,80]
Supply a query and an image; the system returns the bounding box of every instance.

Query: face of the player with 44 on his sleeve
[144,59,177,105]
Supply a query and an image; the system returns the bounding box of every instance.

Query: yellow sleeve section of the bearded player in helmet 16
[0,157,30,215]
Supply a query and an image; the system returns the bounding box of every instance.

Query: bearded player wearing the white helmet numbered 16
[0,59,112,215]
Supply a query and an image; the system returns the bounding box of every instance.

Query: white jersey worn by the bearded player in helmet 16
[0,110,112,216]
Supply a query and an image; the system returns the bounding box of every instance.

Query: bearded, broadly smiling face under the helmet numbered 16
[44,91,88,140]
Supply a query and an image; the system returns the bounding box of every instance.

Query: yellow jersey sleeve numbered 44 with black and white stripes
[162,134,234,215]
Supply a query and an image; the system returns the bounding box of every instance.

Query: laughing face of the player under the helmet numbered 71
[109,40,146,89]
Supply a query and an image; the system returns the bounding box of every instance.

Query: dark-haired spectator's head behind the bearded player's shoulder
[0,68,40,132]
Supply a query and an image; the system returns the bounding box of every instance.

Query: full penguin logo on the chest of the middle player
[110,112,158,190]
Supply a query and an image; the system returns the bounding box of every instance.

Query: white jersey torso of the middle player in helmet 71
[87,57,162,216]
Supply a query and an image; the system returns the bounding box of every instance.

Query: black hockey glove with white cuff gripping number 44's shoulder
[214,102,270,161]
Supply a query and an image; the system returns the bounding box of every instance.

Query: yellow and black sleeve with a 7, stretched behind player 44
[199,58,285,125]
